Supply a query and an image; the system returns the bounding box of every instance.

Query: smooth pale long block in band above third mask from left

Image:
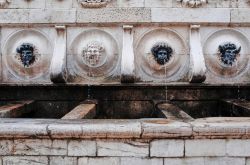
[151,8,230,23]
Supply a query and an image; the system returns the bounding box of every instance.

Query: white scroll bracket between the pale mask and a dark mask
[121,25,135,83]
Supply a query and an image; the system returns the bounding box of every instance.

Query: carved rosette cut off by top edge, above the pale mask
[78,0,110,8]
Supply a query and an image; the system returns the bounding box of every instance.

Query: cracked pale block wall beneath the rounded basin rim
[1,139,250,165]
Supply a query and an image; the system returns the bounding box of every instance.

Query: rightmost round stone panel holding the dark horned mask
[203,29,250,82]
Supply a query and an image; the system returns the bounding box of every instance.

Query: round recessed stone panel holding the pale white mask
[68,29,120,82]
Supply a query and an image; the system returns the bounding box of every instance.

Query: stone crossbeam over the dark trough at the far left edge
[0,101,34,118]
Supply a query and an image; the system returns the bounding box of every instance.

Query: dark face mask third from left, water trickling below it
[151,43,173,65]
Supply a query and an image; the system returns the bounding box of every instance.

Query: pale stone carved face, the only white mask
[83,41,104,66]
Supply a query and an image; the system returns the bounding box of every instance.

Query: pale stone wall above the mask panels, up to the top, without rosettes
[0,0,250,24]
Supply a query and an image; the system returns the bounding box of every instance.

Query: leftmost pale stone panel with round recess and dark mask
[2,29,53,82]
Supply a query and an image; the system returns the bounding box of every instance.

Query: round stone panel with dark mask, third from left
[135,29,189,82]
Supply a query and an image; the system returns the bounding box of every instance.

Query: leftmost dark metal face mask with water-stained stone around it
[16,43,36,67]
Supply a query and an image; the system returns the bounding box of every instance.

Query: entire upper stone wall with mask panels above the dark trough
[0,0,250,84]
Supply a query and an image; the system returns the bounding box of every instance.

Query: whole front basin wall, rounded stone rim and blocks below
[0,118,250,165]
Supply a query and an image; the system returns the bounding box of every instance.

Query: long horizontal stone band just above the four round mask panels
[0,7,250,25]
